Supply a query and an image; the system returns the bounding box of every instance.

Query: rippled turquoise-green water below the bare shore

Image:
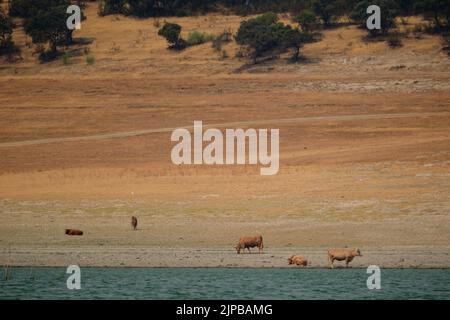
[0,268,450,299]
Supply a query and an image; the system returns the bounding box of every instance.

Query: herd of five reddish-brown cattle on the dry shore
[66,216,362,268]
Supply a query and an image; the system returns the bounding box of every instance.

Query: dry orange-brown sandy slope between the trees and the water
[0,5,450,268]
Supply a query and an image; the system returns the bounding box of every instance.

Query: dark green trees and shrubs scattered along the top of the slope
[0,0,450,63]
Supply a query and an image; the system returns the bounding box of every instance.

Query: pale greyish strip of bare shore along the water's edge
[0,247,450,269]
